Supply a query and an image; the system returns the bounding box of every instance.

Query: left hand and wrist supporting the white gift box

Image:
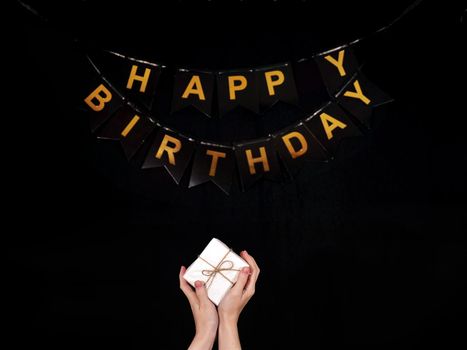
[179,266,219,350]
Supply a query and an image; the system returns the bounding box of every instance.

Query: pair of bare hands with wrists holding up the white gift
[179,250,260,350]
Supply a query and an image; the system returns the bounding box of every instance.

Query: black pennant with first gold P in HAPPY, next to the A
[217,70,259,116]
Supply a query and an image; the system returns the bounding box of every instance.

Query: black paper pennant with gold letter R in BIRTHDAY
[142,128,195,184]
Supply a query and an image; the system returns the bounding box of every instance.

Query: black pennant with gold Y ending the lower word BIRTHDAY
[336,73,392,128]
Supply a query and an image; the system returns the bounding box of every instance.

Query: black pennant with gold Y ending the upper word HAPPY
[315,48,359,96]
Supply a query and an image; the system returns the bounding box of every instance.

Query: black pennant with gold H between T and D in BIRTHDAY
[235,138,281,191]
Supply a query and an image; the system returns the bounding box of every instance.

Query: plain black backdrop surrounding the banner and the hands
[2,1,467,349]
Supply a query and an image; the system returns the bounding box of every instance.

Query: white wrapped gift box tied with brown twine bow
[183,238,249,305]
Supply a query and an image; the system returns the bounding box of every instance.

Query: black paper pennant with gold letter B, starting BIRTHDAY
[80,73,124,132]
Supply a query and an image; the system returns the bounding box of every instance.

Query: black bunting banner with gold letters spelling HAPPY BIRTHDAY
[81,43,391,194]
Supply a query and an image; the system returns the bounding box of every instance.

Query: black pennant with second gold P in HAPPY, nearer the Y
[255,63,298,112]
